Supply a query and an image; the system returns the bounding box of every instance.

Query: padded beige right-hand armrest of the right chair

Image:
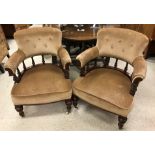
[132,56,147,82]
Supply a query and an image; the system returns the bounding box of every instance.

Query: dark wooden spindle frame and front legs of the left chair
[5,54,72,117]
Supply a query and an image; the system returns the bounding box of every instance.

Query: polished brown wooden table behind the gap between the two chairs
[61,24,99,61]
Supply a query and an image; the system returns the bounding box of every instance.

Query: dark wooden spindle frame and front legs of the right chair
[72,56,142,129]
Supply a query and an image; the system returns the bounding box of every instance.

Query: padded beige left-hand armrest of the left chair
[4,50,26,76]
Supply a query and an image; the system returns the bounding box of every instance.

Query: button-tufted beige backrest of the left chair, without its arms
[14,27,62,57]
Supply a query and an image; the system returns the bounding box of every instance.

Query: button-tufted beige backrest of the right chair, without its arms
[96,28,149,64]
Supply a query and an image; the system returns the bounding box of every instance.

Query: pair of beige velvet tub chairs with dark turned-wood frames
[5,27,148,129]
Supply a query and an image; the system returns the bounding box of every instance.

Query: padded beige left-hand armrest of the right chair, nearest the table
[76,46,99,68]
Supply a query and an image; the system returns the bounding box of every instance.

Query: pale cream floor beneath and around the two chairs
[0,40,155,131]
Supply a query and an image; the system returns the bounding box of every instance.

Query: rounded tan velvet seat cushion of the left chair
[11,64,72,104]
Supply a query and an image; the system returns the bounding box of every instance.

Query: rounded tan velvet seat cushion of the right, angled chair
[73,68,133,110]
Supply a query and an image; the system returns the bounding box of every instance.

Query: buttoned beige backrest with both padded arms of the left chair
[5,27,71,74]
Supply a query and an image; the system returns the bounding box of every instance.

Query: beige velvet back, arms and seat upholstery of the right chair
[72,28,148,118]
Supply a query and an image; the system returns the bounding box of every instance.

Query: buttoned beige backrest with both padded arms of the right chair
[76,28,148,81]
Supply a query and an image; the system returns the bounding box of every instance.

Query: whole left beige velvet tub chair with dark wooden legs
[5,27,72,110]
